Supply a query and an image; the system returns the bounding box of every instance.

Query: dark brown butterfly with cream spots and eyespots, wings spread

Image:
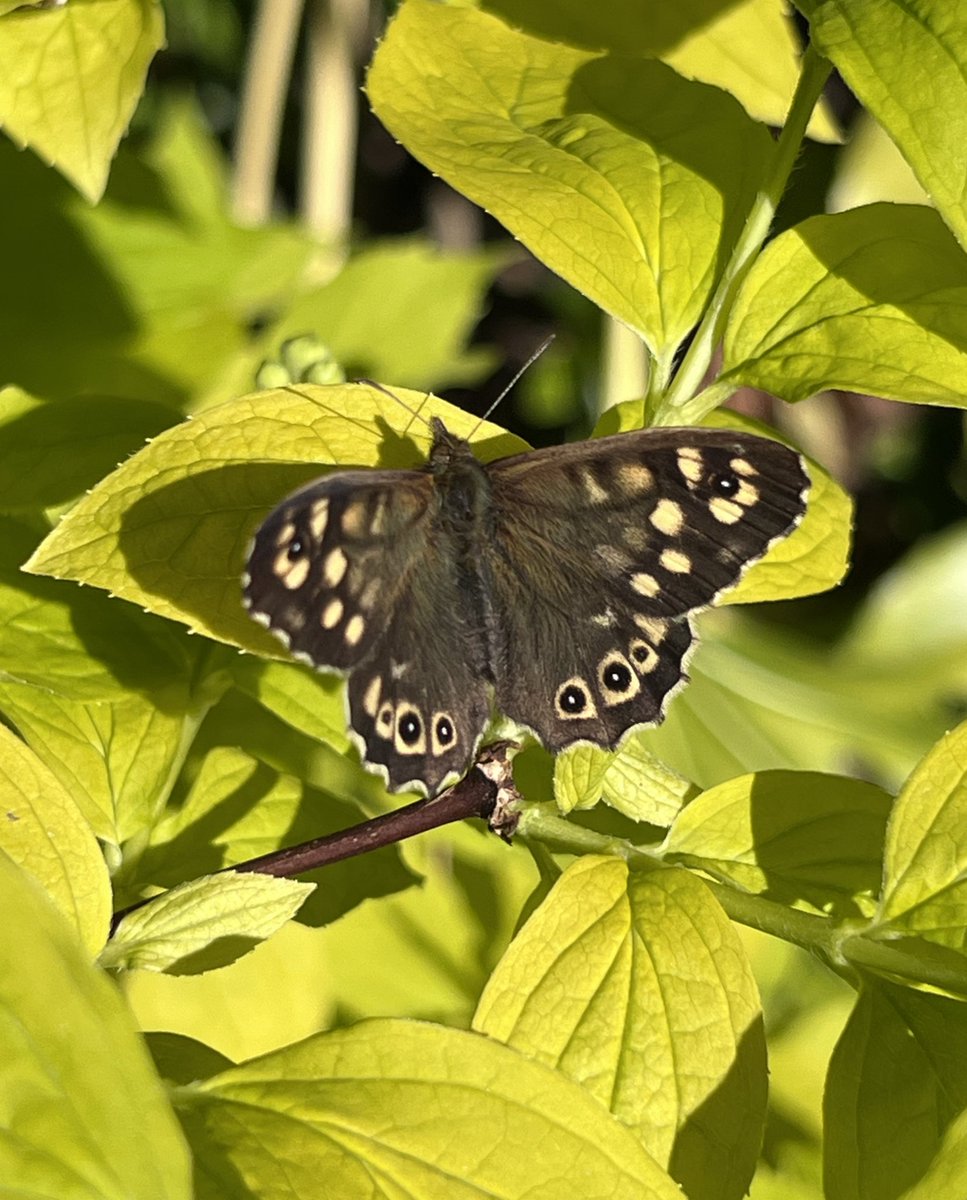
[242,418,810,796]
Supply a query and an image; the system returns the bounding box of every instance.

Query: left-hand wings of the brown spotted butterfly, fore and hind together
[244,470,489,796]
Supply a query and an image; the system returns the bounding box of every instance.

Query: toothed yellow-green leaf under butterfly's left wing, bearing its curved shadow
[24,384,522,658]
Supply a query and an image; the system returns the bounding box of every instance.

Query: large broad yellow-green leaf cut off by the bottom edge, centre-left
[175,1020,680,1200]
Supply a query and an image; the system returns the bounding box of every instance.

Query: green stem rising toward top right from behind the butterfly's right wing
[655,46,831,425]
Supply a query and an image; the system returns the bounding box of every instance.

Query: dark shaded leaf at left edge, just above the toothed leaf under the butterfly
[0,388,178,512]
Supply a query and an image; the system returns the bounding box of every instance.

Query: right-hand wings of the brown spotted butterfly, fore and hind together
[485,428,809,750]
